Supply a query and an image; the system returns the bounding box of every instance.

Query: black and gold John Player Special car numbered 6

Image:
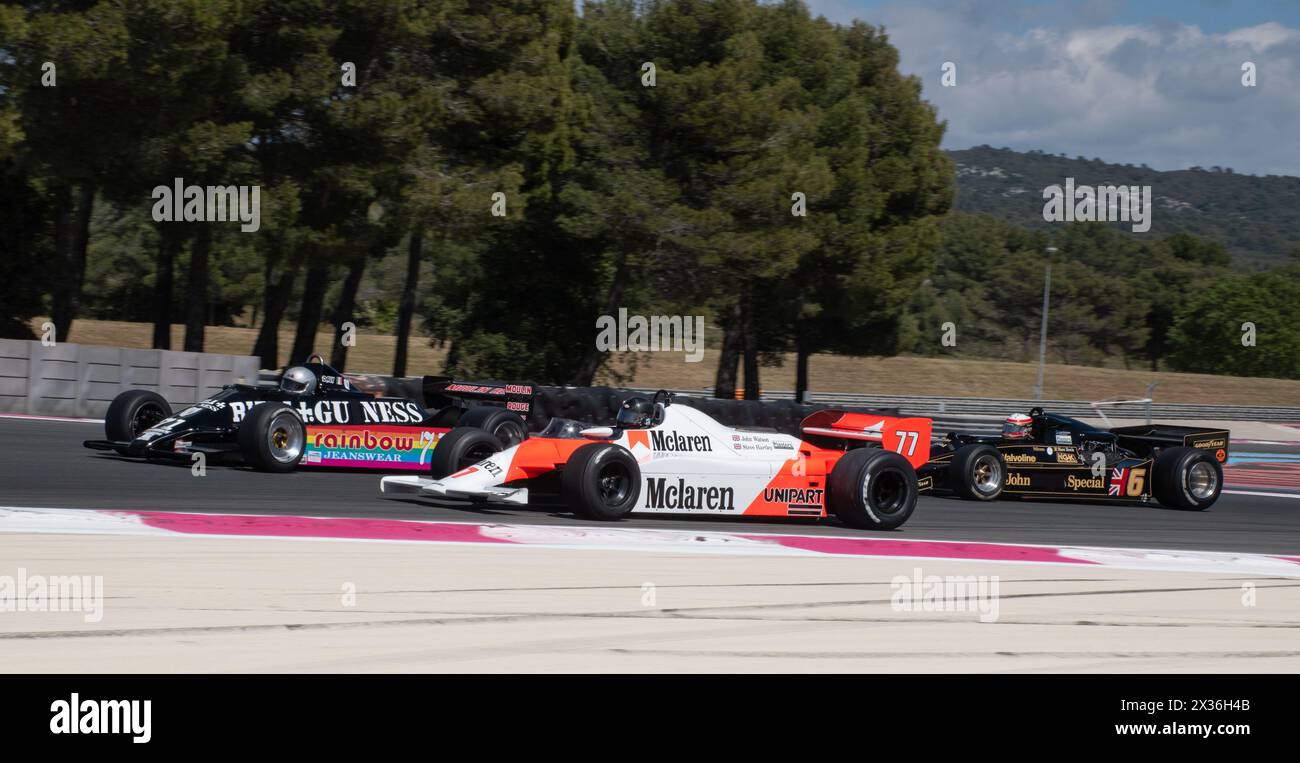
[917,408,1229,511]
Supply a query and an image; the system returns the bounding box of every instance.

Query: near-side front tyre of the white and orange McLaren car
[560,442,641,521]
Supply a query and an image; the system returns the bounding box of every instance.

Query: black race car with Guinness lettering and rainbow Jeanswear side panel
[85,356,533,472]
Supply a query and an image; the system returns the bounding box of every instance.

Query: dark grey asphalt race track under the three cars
[0,419,1300,555]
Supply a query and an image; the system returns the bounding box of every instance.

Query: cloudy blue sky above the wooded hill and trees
[806,0,1300,175]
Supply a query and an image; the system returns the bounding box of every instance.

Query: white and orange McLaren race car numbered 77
[381,391,931,529]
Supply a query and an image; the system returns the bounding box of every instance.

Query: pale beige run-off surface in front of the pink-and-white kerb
[0,533,1300,673]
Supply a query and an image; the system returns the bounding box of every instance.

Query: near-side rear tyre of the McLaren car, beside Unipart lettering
[827,447,918,530]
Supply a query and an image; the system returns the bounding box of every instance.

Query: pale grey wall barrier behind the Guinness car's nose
[0,339,260,419]
